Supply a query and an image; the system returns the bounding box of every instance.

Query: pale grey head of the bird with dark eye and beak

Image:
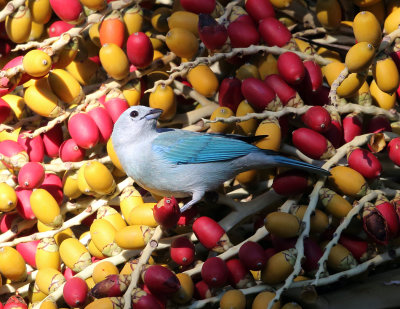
[112,105,162,142]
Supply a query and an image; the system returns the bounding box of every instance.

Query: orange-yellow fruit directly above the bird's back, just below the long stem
[187,64,219,98]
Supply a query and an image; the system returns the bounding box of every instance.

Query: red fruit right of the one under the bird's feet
[192,216,227,249]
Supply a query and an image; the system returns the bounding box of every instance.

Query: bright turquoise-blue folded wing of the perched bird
[152,130,259,164]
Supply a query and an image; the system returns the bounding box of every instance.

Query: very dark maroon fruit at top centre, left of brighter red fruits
[198,14,228,50]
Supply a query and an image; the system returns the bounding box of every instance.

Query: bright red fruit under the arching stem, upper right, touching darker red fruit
[278,52,305,85]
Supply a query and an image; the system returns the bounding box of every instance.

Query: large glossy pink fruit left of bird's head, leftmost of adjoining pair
[68,113,100,149]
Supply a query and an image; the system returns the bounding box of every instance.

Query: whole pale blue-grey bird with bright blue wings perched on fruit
[111,106,329,212]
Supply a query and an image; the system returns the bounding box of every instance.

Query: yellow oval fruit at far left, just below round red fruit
[30,189,63,227]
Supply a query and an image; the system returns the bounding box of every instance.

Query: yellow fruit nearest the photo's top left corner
[5,6,32,43]
